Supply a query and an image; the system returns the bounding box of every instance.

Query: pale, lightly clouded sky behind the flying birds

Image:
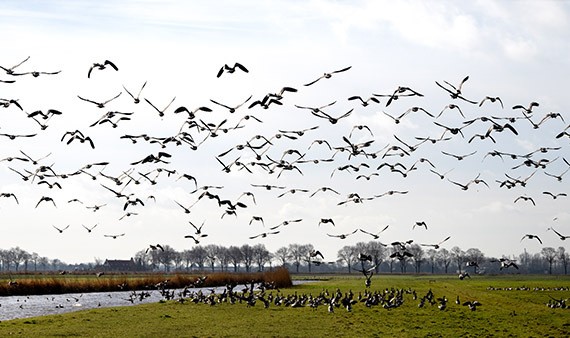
[0,0,570,263]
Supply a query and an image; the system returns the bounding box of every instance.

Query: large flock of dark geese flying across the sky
[0,57,570,266]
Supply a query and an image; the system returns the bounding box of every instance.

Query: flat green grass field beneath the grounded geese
[0,275,570,337]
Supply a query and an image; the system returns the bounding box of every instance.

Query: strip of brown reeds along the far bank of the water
[0,268,292,296]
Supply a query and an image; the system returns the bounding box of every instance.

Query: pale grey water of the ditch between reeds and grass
[0,281,306,321]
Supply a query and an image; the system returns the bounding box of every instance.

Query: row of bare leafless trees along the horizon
[0,241,570,274]
